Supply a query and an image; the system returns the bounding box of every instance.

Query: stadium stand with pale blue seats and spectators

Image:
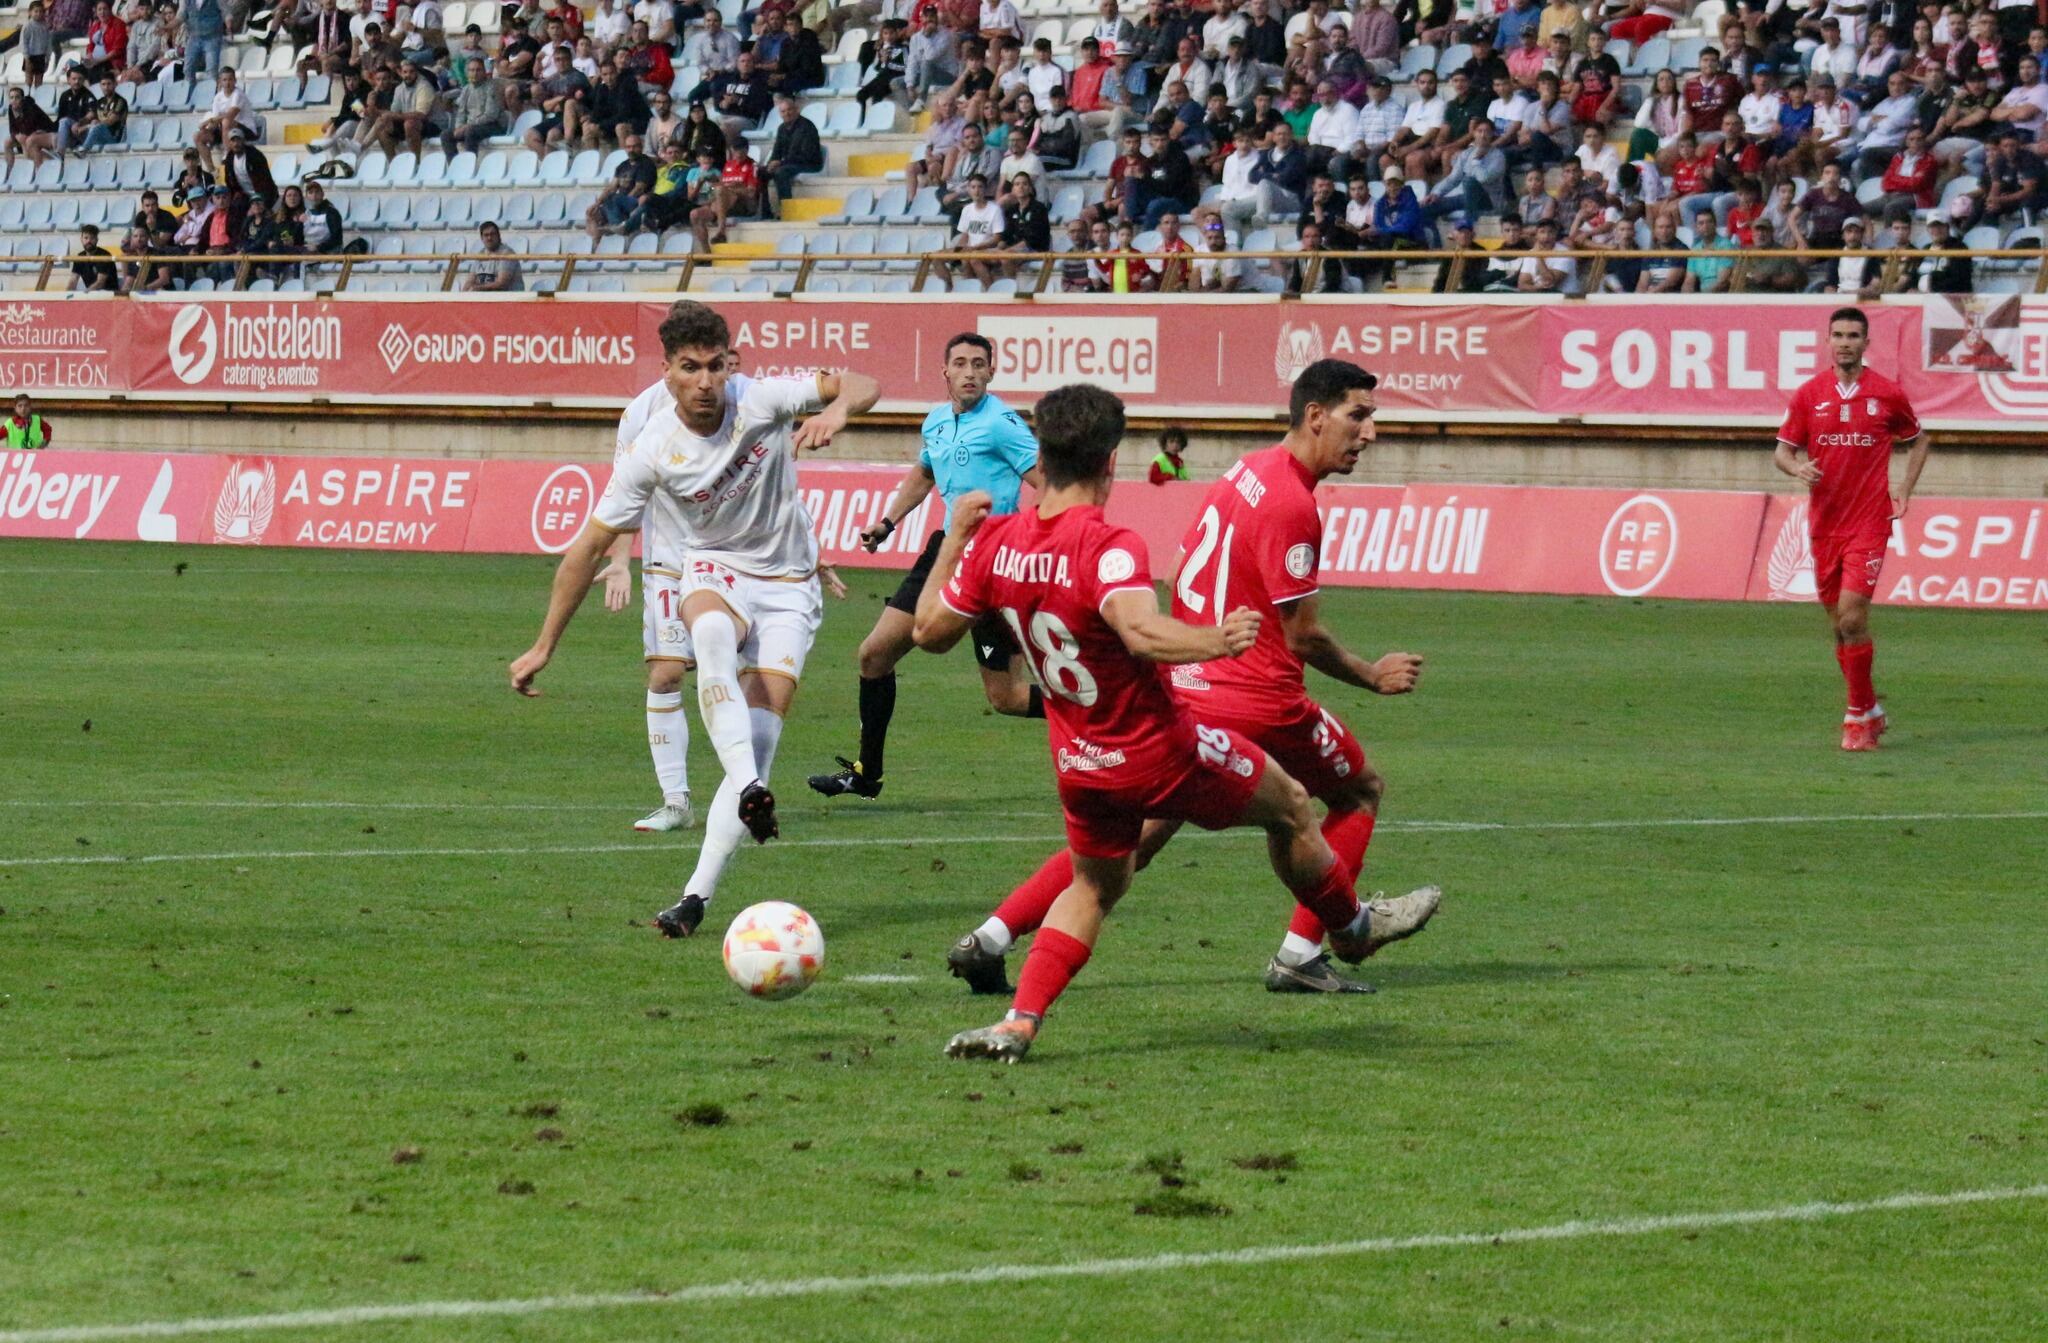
[0,0,2048,297]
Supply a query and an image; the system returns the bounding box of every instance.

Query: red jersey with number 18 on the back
[940,508,1196,790]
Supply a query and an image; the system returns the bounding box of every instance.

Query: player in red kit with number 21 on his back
[946,358,1440,993]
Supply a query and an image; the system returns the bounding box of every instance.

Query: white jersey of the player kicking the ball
[594,375,821,577]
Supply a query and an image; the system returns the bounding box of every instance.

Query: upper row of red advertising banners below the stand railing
[0,295,2048,430]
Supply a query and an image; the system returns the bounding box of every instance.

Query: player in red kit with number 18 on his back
[913,376,1425,1060]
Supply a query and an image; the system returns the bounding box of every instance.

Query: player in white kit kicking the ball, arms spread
[510,303,881,938]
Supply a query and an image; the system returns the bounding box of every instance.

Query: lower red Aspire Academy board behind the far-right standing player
[1747,495,2048,610]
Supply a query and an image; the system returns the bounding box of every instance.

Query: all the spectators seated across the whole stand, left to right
[4,0,2048,293]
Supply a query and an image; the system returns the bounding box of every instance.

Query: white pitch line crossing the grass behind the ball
[0,811,2048,868]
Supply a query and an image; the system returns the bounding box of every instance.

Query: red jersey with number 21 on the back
[1174,446,1323,725]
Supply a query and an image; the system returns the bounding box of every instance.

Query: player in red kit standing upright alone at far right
[1774,307,1927,751]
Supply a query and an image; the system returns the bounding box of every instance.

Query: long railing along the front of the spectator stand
[16,248,2048,299]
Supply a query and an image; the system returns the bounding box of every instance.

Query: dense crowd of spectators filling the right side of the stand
[860,0,2048,293]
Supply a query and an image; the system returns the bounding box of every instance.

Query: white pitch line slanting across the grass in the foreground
[0,1185,2048,1343]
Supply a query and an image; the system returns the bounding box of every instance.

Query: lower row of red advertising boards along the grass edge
[12,450,2048,610]
